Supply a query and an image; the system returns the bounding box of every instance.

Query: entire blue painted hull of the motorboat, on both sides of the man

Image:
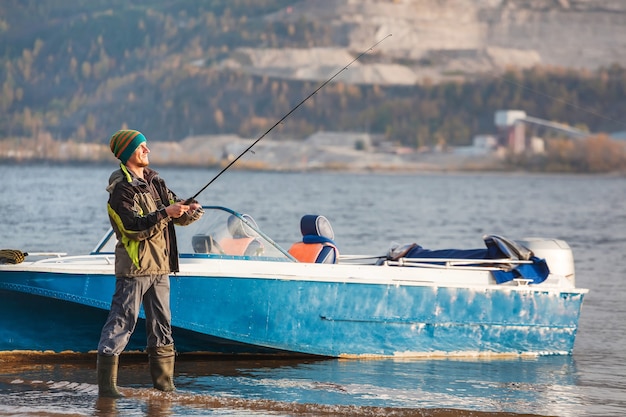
[0,271,584,357]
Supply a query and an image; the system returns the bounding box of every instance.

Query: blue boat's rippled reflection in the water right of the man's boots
[177,356,580,416]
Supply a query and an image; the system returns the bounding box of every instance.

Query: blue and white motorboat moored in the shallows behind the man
[0,206,588,358]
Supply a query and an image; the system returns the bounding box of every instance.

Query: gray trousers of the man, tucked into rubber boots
[98,275,174,356]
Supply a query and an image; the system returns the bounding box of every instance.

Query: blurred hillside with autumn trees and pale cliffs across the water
[0,0,626,148]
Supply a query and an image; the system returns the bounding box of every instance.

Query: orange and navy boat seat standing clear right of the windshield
[289,214,339,264]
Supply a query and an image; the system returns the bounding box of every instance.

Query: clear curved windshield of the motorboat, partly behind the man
[92,206,293,261]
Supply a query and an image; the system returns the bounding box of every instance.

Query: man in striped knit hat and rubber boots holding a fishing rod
[97,130,203,397]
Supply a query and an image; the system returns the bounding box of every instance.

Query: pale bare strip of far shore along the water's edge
[0,135,624,174]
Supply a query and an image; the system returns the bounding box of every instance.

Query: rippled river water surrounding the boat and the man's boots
[0,166,626,417]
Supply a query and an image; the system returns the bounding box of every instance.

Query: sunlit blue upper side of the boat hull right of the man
[172,278,583,356]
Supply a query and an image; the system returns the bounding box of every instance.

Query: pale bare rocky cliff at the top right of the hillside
[222,0,626,84]
